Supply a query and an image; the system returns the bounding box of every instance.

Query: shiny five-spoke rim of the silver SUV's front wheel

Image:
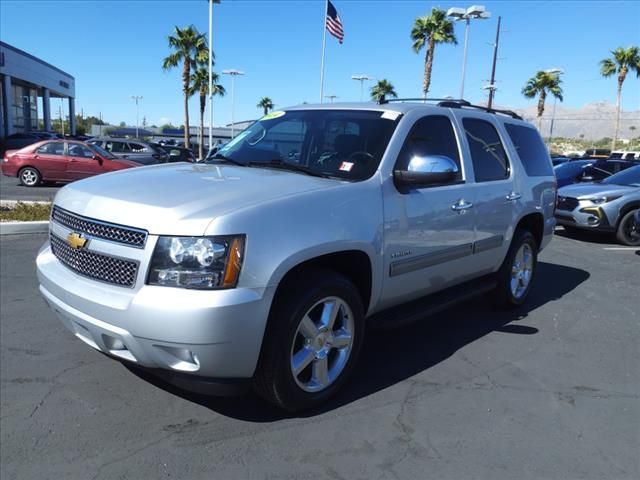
[289,297,354,393]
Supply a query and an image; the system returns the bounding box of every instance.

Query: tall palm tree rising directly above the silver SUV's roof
[411,8,458,98]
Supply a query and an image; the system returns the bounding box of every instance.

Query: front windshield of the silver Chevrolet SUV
[209,110,400,181]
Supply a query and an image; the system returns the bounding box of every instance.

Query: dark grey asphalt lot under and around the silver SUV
[0,231,640,480]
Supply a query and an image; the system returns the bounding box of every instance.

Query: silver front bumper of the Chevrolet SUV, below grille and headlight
[36,242,275,378]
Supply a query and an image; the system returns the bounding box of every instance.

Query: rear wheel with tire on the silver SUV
[496,230,538,308]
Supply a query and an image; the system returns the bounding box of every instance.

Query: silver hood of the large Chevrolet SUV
[55,163,341,235]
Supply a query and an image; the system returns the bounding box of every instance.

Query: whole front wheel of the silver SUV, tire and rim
[254,271,364,411]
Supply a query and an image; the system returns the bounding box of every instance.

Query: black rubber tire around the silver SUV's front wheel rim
[253,270,364,412]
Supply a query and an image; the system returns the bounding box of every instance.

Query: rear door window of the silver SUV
[462,118,509,182]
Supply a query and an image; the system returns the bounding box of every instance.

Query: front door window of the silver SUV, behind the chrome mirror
[396,115,462,180]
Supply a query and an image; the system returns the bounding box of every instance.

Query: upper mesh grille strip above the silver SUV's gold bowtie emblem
[51,206,147,248]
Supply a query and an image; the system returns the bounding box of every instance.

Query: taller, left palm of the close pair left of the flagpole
[162,25,209,148]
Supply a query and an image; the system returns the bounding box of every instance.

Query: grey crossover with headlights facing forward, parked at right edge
[555,165,640,246]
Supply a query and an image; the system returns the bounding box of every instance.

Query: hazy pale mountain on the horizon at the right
[498,100,640,140]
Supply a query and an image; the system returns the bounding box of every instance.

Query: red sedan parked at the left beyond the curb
[2,140,140,187]
